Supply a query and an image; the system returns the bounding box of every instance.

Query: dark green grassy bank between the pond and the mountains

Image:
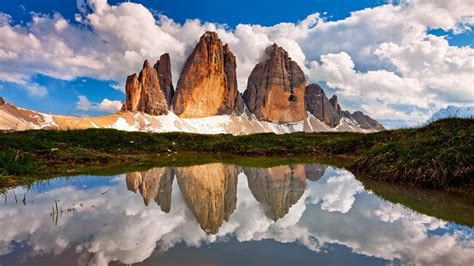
[0,119,474,188]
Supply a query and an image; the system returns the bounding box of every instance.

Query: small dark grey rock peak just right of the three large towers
[304,84,341,127]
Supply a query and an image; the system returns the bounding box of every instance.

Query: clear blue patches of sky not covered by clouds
[0,0,383,115]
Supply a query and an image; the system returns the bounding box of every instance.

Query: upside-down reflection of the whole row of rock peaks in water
[126,163,326,234]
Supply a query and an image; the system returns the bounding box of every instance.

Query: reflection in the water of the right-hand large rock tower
[243,165,306,221]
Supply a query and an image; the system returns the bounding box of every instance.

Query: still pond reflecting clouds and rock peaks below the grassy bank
[0,163,474,266]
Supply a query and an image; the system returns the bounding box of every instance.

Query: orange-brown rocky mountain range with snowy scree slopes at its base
[0,32,384,135]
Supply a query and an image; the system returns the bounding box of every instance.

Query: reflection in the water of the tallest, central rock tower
[176,163,239,234]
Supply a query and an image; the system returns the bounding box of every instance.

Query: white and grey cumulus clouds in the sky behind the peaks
[0,0,474,127]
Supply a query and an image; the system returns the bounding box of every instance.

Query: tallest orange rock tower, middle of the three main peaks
[173,32,243,118]
